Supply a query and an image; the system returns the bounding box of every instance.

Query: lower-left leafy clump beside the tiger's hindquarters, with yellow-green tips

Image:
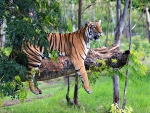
[0,47,27,104]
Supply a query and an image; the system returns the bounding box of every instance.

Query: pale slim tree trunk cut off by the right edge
[145,7,150,43]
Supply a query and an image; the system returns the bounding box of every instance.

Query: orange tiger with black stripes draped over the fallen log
[23,20,102,94]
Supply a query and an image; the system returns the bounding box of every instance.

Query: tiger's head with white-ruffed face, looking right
[85,20,102,41]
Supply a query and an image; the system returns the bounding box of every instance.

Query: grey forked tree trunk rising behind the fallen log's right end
[113,0,129,106]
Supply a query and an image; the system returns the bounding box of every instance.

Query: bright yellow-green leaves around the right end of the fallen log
[89,46,148,83]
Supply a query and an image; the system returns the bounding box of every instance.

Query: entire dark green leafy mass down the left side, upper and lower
[0,0,60,101]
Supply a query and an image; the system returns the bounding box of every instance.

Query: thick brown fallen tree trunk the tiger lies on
[36,46,130,81]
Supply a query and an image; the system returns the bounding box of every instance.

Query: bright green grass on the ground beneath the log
[0,69,150,113]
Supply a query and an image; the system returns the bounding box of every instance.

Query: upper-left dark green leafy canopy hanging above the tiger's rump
[0,0,60,49]
